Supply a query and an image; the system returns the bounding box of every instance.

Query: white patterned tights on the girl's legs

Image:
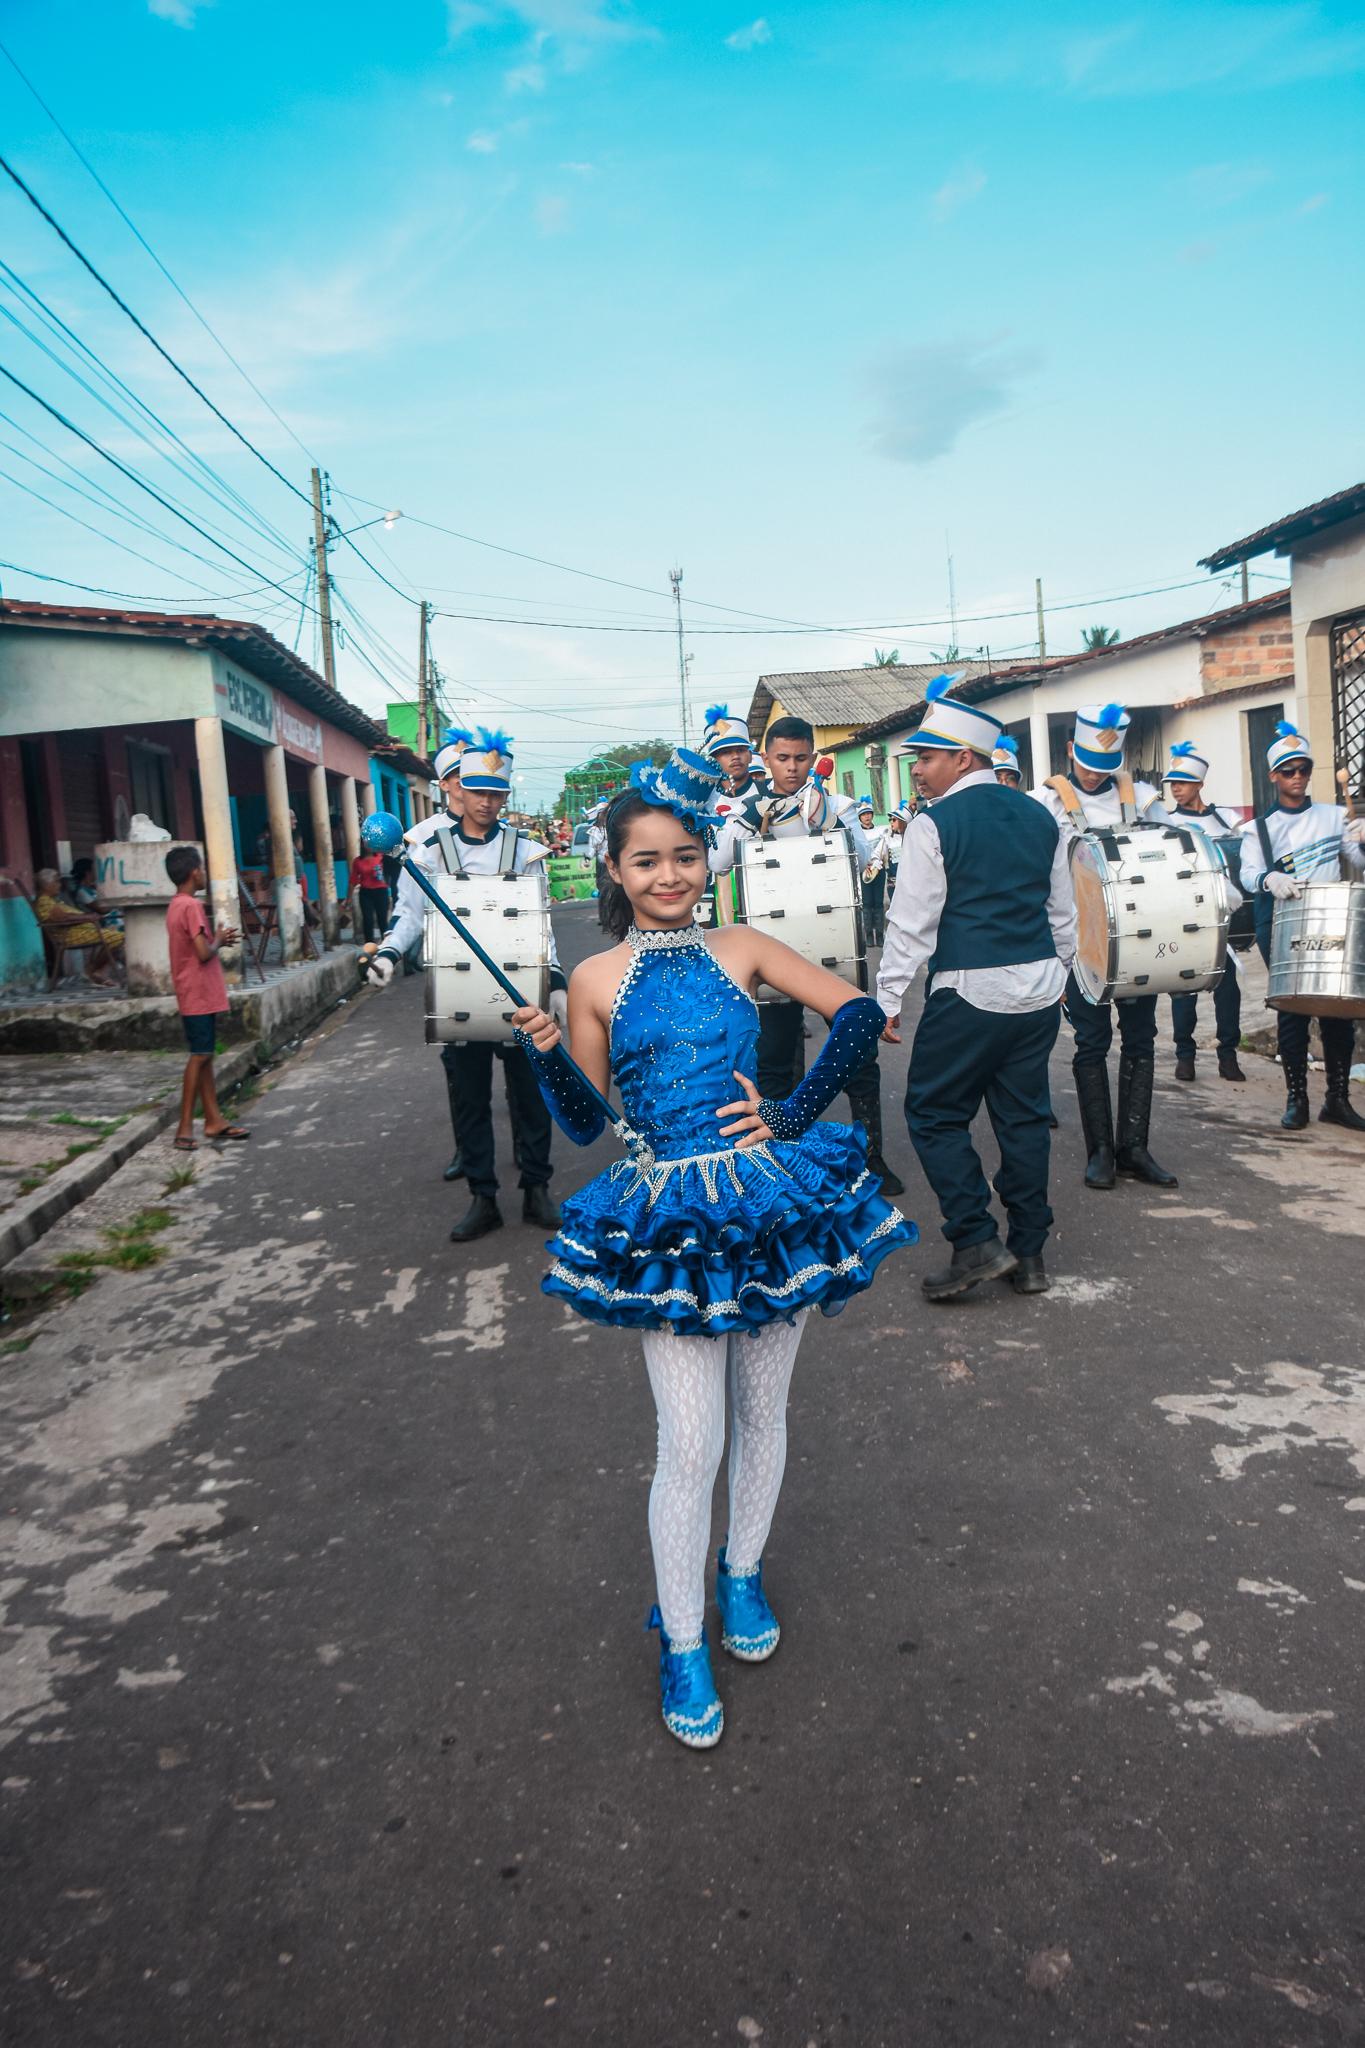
[645,1311,804,1645]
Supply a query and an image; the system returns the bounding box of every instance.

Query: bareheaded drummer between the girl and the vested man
[710,719,905,1196]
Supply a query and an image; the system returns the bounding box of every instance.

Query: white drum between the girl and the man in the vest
[735,831,868,1004]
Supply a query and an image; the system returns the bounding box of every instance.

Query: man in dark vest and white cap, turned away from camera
[876,684,1076,1300]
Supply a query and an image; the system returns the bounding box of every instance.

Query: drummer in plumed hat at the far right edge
[1242,719,1365,1130]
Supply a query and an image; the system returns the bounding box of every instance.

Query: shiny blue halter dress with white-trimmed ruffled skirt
[542,928,919,1337]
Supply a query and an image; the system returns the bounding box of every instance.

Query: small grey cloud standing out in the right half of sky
[868,336,1042,463]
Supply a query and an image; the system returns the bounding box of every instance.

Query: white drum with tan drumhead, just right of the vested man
[1070,825,1232,1004]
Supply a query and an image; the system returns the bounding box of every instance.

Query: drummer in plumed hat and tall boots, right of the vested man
[1029,705,1177,1188]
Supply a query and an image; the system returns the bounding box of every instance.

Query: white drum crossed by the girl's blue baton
[422,866,551,1044]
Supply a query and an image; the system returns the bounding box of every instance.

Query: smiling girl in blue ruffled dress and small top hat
[514,752,917,1749]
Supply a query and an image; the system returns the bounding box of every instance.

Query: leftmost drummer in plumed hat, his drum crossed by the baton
[370,727,567,1245]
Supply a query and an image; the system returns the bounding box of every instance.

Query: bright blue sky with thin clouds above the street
[0,0,1365,797]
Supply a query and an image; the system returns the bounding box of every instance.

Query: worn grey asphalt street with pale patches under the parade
[0,905,1365,2048]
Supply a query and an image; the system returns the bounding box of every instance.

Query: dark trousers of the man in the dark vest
[905,989,1062,1260]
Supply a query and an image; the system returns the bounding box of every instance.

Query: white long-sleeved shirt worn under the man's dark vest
[876,768,1076,1024]
